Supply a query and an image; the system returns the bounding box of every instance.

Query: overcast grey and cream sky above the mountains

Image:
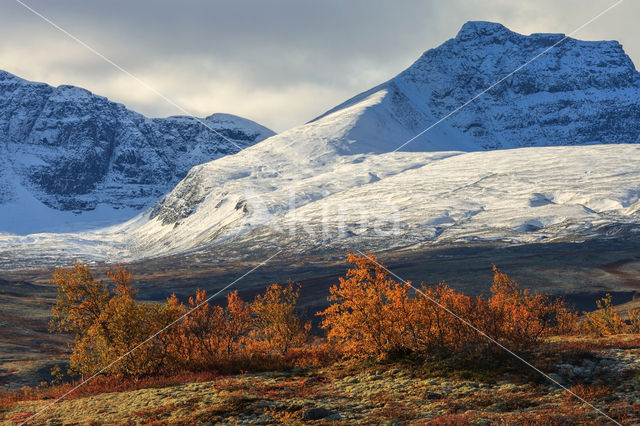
[0,0,640,131]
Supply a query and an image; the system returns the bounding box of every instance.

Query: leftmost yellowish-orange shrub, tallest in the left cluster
[51,262,179,375]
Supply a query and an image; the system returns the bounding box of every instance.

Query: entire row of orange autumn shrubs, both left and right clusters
[52,254,584,377]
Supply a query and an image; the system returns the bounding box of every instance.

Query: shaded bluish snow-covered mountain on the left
[0,71,274,233]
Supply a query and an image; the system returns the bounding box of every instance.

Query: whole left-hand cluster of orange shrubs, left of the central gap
[51,263,312,377]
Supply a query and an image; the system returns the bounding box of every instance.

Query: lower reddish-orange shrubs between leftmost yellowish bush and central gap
[167,283,311,371]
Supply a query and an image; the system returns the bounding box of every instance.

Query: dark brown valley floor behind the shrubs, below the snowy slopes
[0,238,640,389]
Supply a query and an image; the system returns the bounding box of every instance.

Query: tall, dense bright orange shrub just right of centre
[319,254,479,360]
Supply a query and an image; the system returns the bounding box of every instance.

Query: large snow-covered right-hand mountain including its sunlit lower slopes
[0,22,640,266]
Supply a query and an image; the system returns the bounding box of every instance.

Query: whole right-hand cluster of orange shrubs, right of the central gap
[319,254,576,359]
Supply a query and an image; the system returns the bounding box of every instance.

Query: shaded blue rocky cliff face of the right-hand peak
[314,22,640,151]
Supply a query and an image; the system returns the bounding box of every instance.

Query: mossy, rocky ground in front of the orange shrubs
[0,336,640,425]
